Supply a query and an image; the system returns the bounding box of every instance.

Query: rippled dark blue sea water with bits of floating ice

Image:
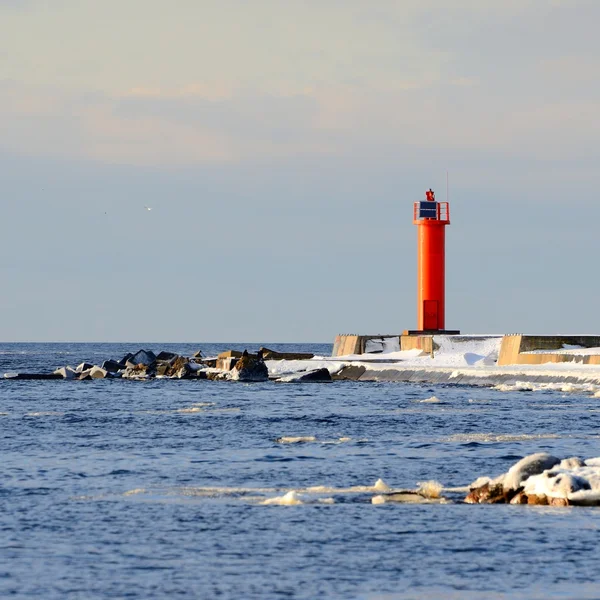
[0,344,600,600]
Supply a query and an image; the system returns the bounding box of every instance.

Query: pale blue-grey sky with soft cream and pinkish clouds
[0,0,600,343]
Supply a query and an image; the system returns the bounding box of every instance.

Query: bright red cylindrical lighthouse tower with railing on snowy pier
[410,189,460,334]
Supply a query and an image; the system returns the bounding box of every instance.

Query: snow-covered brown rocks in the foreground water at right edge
[465,452,600,506]
